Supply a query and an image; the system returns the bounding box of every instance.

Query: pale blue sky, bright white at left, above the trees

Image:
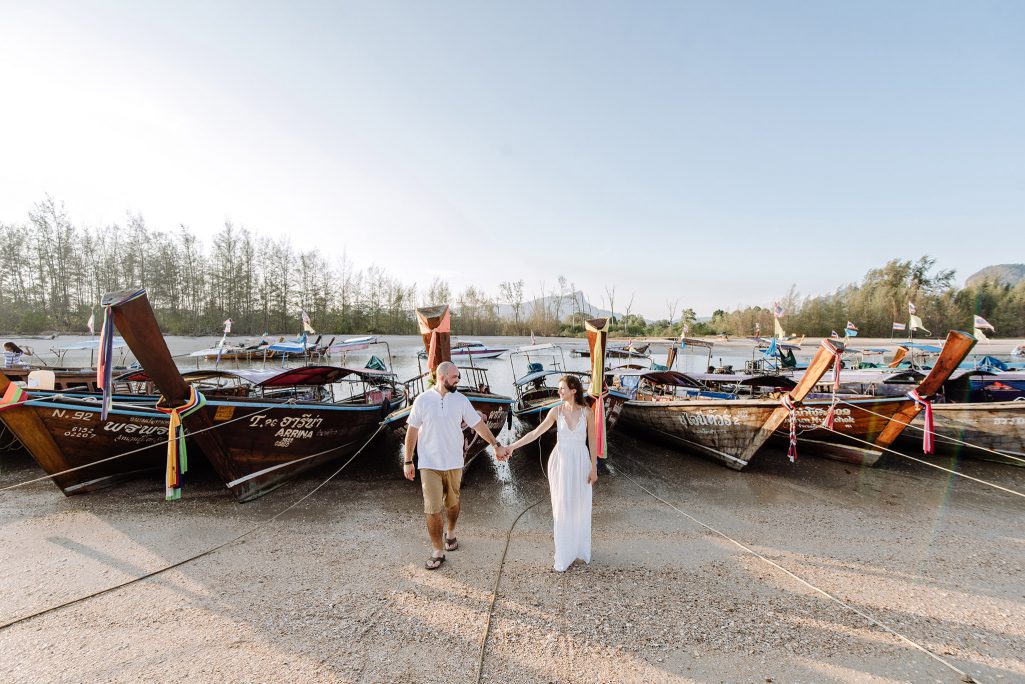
[0,0,1025,318]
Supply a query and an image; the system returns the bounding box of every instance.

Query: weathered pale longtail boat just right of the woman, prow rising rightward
[620,339,844,471]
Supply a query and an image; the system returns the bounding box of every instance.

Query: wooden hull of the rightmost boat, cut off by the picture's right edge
[901,401,1025,467]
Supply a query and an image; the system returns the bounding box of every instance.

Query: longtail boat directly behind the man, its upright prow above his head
[384,305,513,469]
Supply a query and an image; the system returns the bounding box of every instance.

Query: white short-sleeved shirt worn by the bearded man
[407,388,481,471]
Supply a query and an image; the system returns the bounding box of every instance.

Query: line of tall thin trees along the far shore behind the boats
[0,203,1025,337]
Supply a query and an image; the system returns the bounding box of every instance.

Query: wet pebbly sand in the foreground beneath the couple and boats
[0,424,1025,683]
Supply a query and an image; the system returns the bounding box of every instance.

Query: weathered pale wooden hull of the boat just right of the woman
[620,399,780,471]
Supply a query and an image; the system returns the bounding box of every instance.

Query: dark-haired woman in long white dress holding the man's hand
[509,375,598,572]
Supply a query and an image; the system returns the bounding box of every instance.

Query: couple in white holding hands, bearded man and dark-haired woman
[403,361,598,572]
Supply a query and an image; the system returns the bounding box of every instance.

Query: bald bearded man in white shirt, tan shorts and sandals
[402,361,508,570]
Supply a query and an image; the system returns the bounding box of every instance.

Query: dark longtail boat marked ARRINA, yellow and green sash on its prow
[91,290,397,501]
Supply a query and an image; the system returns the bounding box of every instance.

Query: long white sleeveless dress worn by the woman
[548,411,591,572]
